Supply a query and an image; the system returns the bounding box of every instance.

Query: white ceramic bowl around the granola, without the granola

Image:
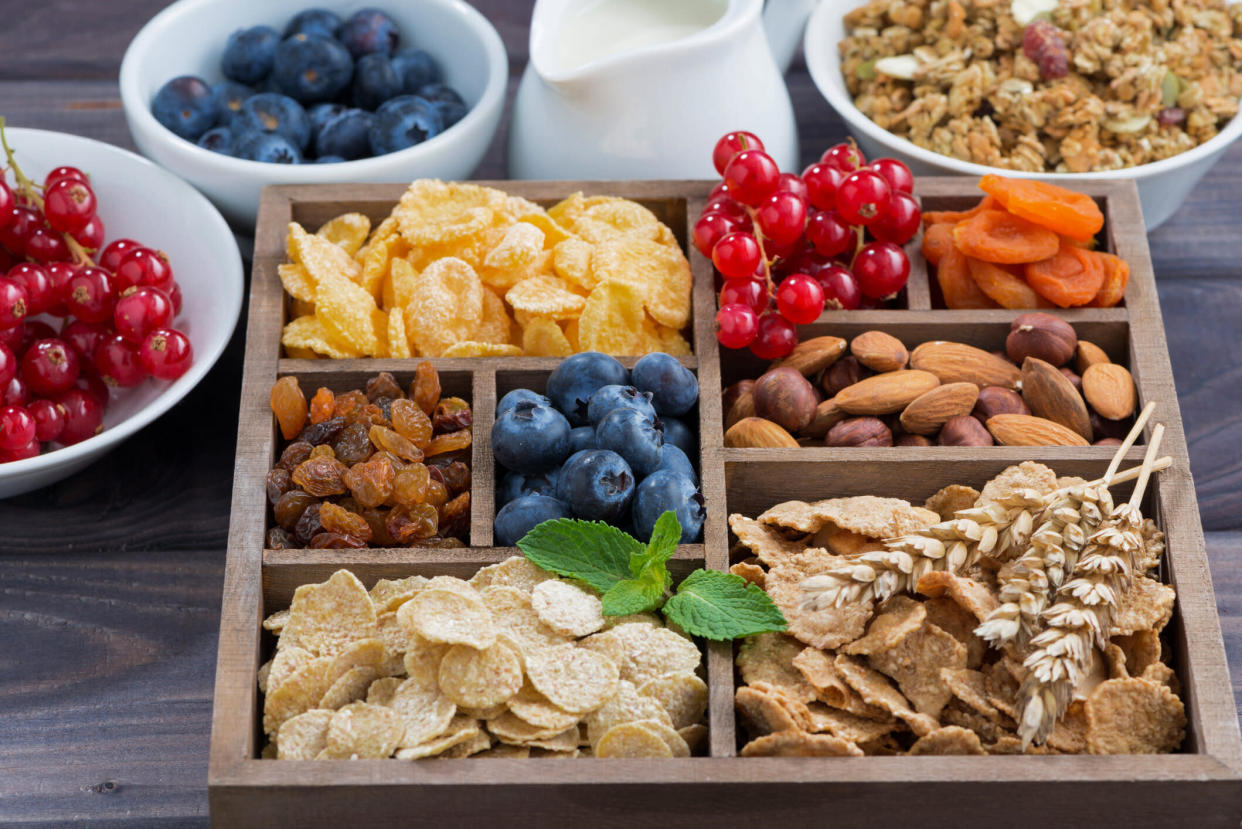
[804,0,1242,230]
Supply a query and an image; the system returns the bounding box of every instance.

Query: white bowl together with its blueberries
[120,0,508,225]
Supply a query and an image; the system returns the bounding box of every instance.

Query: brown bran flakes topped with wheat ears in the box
[729,461,1186,757]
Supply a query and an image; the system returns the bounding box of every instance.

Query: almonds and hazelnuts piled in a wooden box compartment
[722,313,1138,449]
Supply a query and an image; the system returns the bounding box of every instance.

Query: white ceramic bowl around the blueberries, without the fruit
[120,0,509,227]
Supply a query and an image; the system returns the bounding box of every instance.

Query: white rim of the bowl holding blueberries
[119,0,509,176]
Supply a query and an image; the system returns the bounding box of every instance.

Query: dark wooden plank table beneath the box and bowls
[0,0,1242,827]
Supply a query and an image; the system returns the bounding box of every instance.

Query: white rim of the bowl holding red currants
[0,127,245,481]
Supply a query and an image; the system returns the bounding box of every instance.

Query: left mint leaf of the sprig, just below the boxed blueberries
[518,518,645,593]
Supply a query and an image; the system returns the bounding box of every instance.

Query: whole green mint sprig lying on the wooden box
[518,511,786,641]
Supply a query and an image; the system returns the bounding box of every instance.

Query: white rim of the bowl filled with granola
[802,0,1242,181]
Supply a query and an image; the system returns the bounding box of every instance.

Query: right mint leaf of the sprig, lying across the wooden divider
[664,570,786,641]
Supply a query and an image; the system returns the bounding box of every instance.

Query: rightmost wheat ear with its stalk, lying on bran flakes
[1018,424,1164,746]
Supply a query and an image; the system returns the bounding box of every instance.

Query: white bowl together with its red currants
[0,122,242,497]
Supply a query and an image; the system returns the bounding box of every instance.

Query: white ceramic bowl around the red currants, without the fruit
[0,127,242,498]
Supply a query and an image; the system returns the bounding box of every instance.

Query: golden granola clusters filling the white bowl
[840,0,1242,173]
